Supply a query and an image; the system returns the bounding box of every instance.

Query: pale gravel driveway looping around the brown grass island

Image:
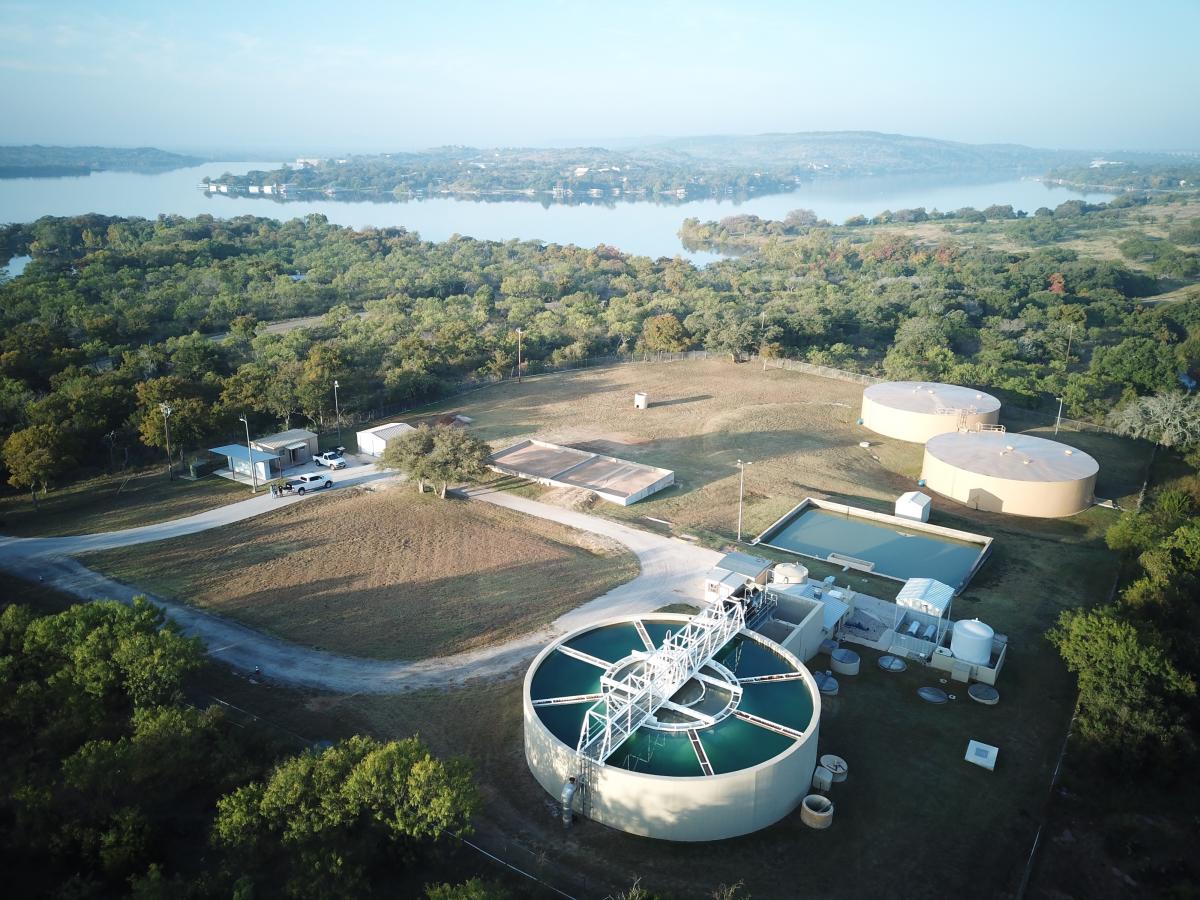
[0,475,720,694]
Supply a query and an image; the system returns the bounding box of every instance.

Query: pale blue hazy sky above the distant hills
[0,0,1200,154]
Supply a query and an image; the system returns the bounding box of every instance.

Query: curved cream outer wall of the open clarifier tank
[524,700,820,841]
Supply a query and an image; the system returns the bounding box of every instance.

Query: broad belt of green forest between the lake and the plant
[0,205,1200,488]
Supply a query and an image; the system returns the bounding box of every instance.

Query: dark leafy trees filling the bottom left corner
[0,595,491,899]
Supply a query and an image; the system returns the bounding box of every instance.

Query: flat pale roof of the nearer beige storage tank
[925,431,1100,481]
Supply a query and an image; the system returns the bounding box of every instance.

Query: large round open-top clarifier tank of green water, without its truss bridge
[524,613,821,841]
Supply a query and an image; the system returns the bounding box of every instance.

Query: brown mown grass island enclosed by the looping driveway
[84,485,638,659]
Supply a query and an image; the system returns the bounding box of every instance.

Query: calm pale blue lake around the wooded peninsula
[0,162,1111,264]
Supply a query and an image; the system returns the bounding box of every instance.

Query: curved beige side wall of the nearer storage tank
[920,449,1096,518]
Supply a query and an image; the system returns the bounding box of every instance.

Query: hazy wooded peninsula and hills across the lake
[201,132,1085,204]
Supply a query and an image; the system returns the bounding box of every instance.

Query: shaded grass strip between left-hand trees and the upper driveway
[0,468,250,538]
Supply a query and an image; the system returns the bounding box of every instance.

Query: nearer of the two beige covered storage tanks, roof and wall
[922,431,1100,518]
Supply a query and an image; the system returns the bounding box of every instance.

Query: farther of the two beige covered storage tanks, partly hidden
[862,382,1000,444]
